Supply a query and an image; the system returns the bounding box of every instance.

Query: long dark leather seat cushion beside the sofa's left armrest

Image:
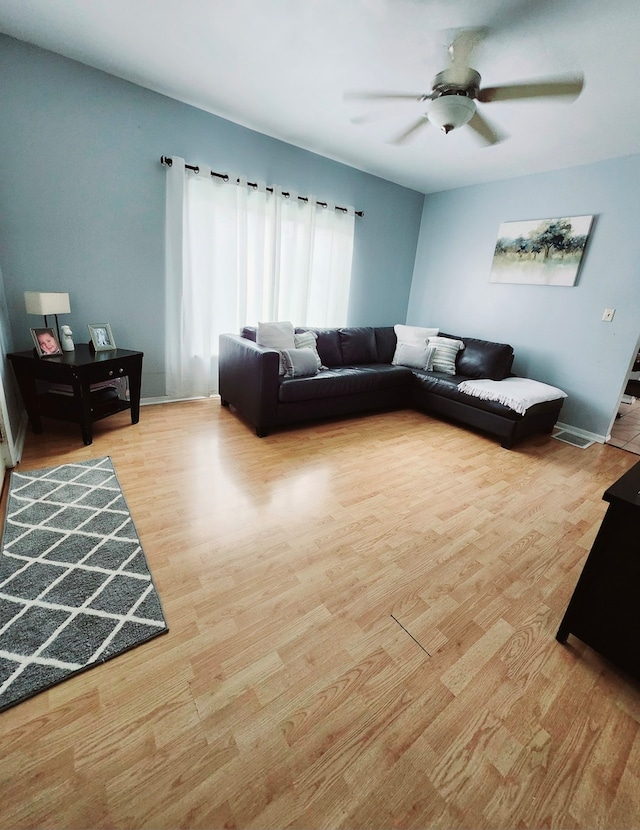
[278,363,413,403]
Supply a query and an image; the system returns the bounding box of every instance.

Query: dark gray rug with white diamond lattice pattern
[0,457,168,711]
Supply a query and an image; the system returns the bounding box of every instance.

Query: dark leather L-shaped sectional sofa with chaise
[219,326,562,449]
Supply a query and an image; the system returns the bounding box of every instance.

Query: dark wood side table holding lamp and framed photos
[7,344,143,444]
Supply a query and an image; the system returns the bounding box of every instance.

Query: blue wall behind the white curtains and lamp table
[0,36,423,397]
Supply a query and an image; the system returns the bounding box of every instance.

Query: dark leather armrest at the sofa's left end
[218,334,280,437]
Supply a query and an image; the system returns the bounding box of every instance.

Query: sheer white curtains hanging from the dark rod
[165,156,355,398]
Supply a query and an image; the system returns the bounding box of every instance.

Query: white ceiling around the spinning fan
[0,0,640,193]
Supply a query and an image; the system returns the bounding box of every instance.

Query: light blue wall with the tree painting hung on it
[408,158,640,436]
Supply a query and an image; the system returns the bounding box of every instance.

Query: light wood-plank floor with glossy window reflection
[0,399,640,828]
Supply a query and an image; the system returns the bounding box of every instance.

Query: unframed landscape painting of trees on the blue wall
[489,216,593,286]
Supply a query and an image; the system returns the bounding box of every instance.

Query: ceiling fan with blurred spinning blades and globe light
[345,29,584,145]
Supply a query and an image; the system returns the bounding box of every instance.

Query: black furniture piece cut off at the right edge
[556,463,640,679]
